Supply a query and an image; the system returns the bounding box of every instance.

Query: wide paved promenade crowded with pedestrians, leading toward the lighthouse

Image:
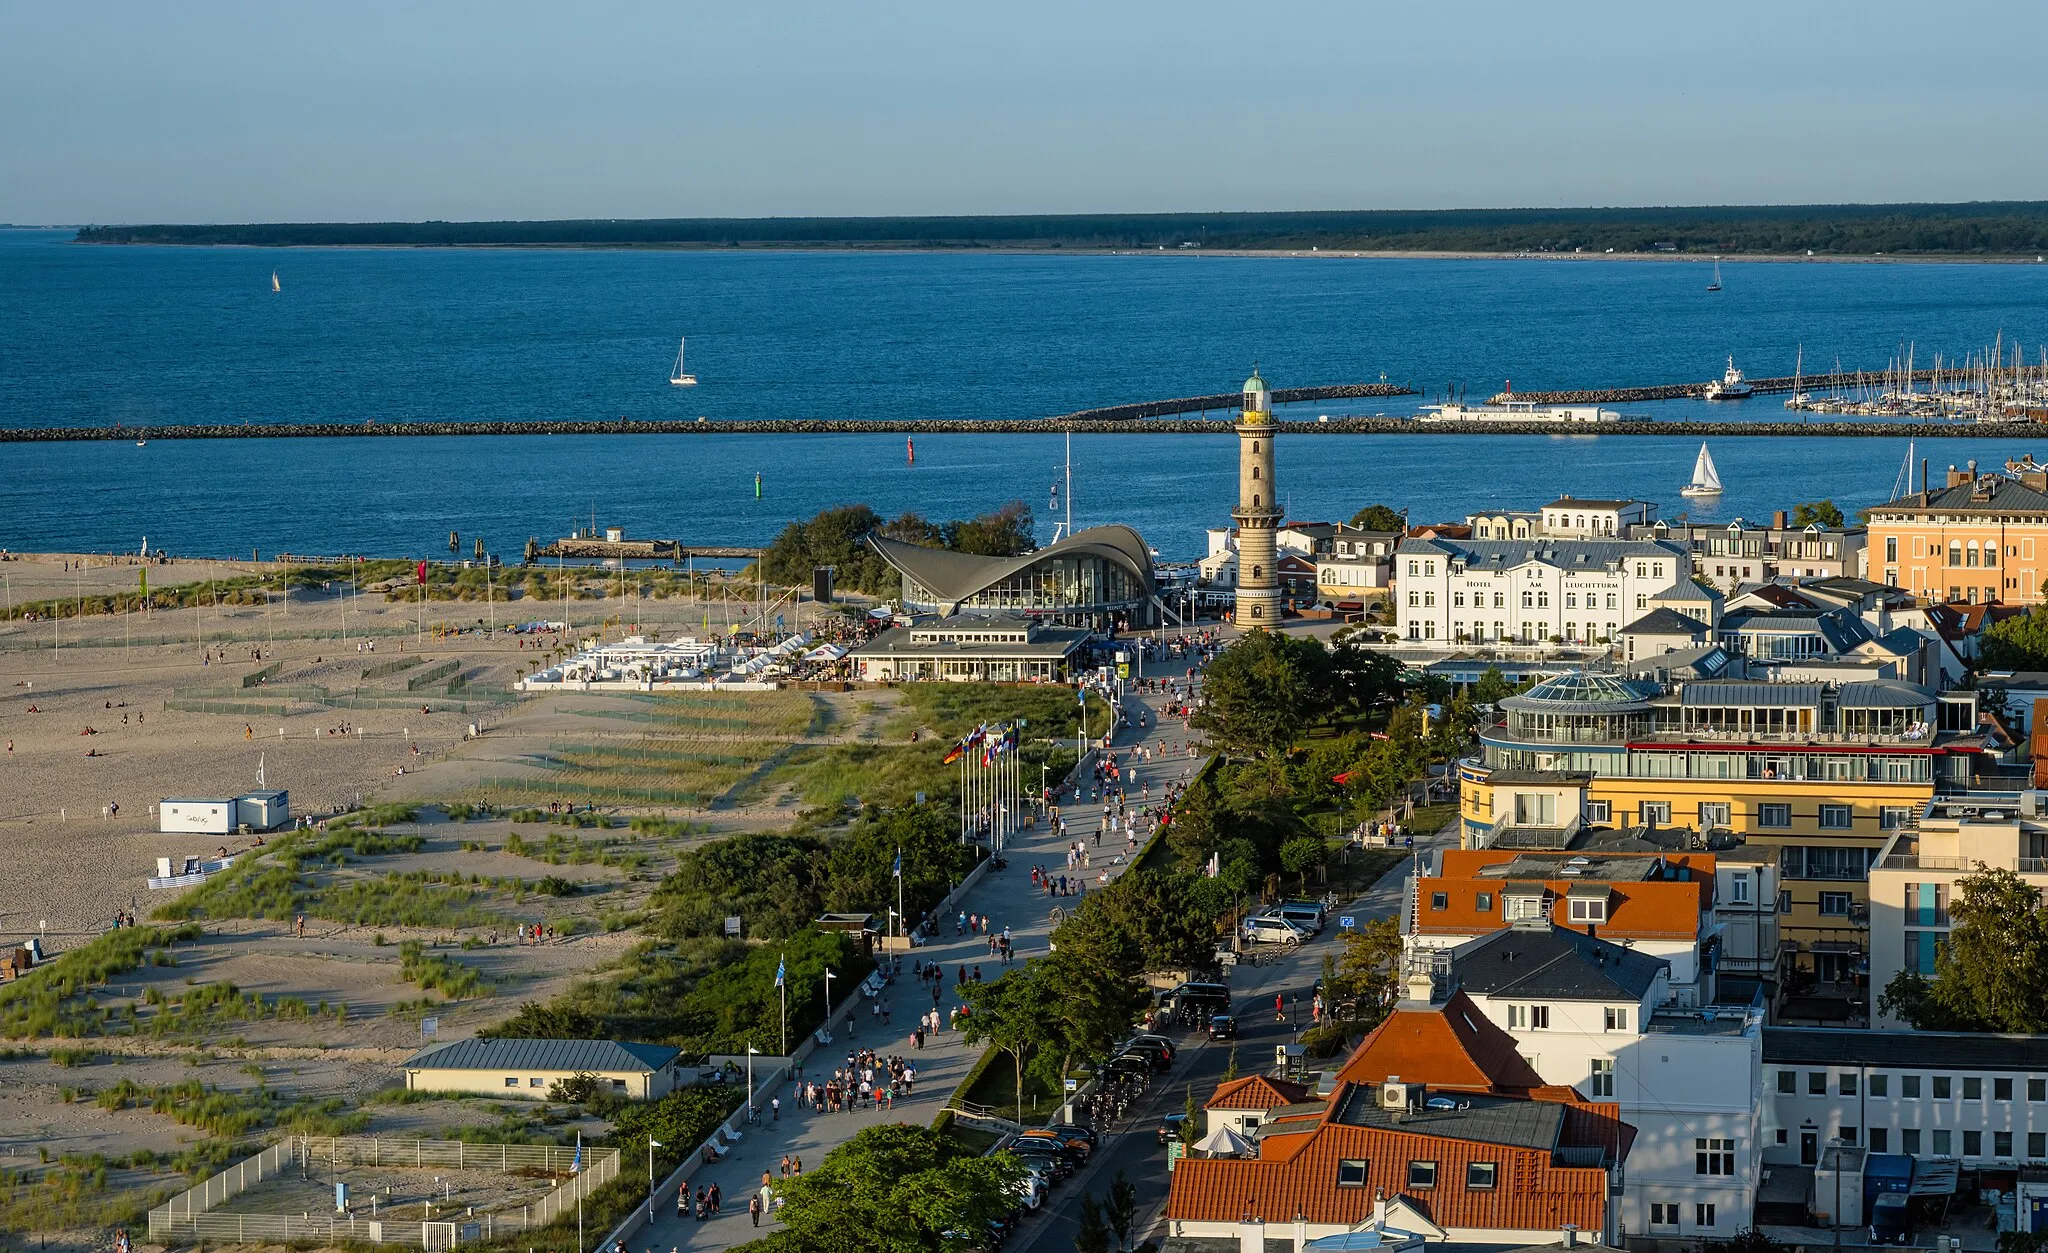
[643,663,1202,1253]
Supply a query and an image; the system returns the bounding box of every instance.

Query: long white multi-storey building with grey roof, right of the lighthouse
[1395,538,1692,643]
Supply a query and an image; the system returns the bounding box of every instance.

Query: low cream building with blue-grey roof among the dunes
[403,1036,682,1101]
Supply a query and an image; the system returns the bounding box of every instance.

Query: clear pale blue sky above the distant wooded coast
[0,0,2048,223]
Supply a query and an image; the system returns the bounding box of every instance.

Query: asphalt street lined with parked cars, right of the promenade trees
[1006,821,1456,1253]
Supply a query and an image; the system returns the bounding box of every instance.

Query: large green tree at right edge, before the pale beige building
[1878,868,2048,1036]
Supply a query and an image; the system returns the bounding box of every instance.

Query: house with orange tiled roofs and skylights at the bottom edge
[1165,995,1634,1247]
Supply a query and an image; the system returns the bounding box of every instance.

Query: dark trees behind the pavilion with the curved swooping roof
[762,500,1038,596]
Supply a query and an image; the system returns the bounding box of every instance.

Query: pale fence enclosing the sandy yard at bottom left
[150,1136,618,1249]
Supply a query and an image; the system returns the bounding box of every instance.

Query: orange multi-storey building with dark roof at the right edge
[1866,461,2048,604]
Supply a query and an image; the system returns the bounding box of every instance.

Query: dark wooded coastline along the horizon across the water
[78,201,2048,256]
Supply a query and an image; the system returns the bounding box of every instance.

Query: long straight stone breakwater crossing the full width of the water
[0,418,2036,444]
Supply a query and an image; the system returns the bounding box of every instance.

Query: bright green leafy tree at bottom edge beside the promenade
[741,1124,1024,1253]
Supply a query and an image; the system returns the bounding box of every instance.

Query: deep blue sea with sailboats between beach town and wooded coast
[0,229,2048,561]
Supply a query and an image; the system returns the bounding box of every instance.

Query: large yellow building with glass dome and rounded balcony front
[1460,674,1980,985]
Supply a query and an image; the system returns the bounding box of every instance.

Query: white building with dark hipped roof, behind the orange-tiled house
[1450,923,1763,1239]
